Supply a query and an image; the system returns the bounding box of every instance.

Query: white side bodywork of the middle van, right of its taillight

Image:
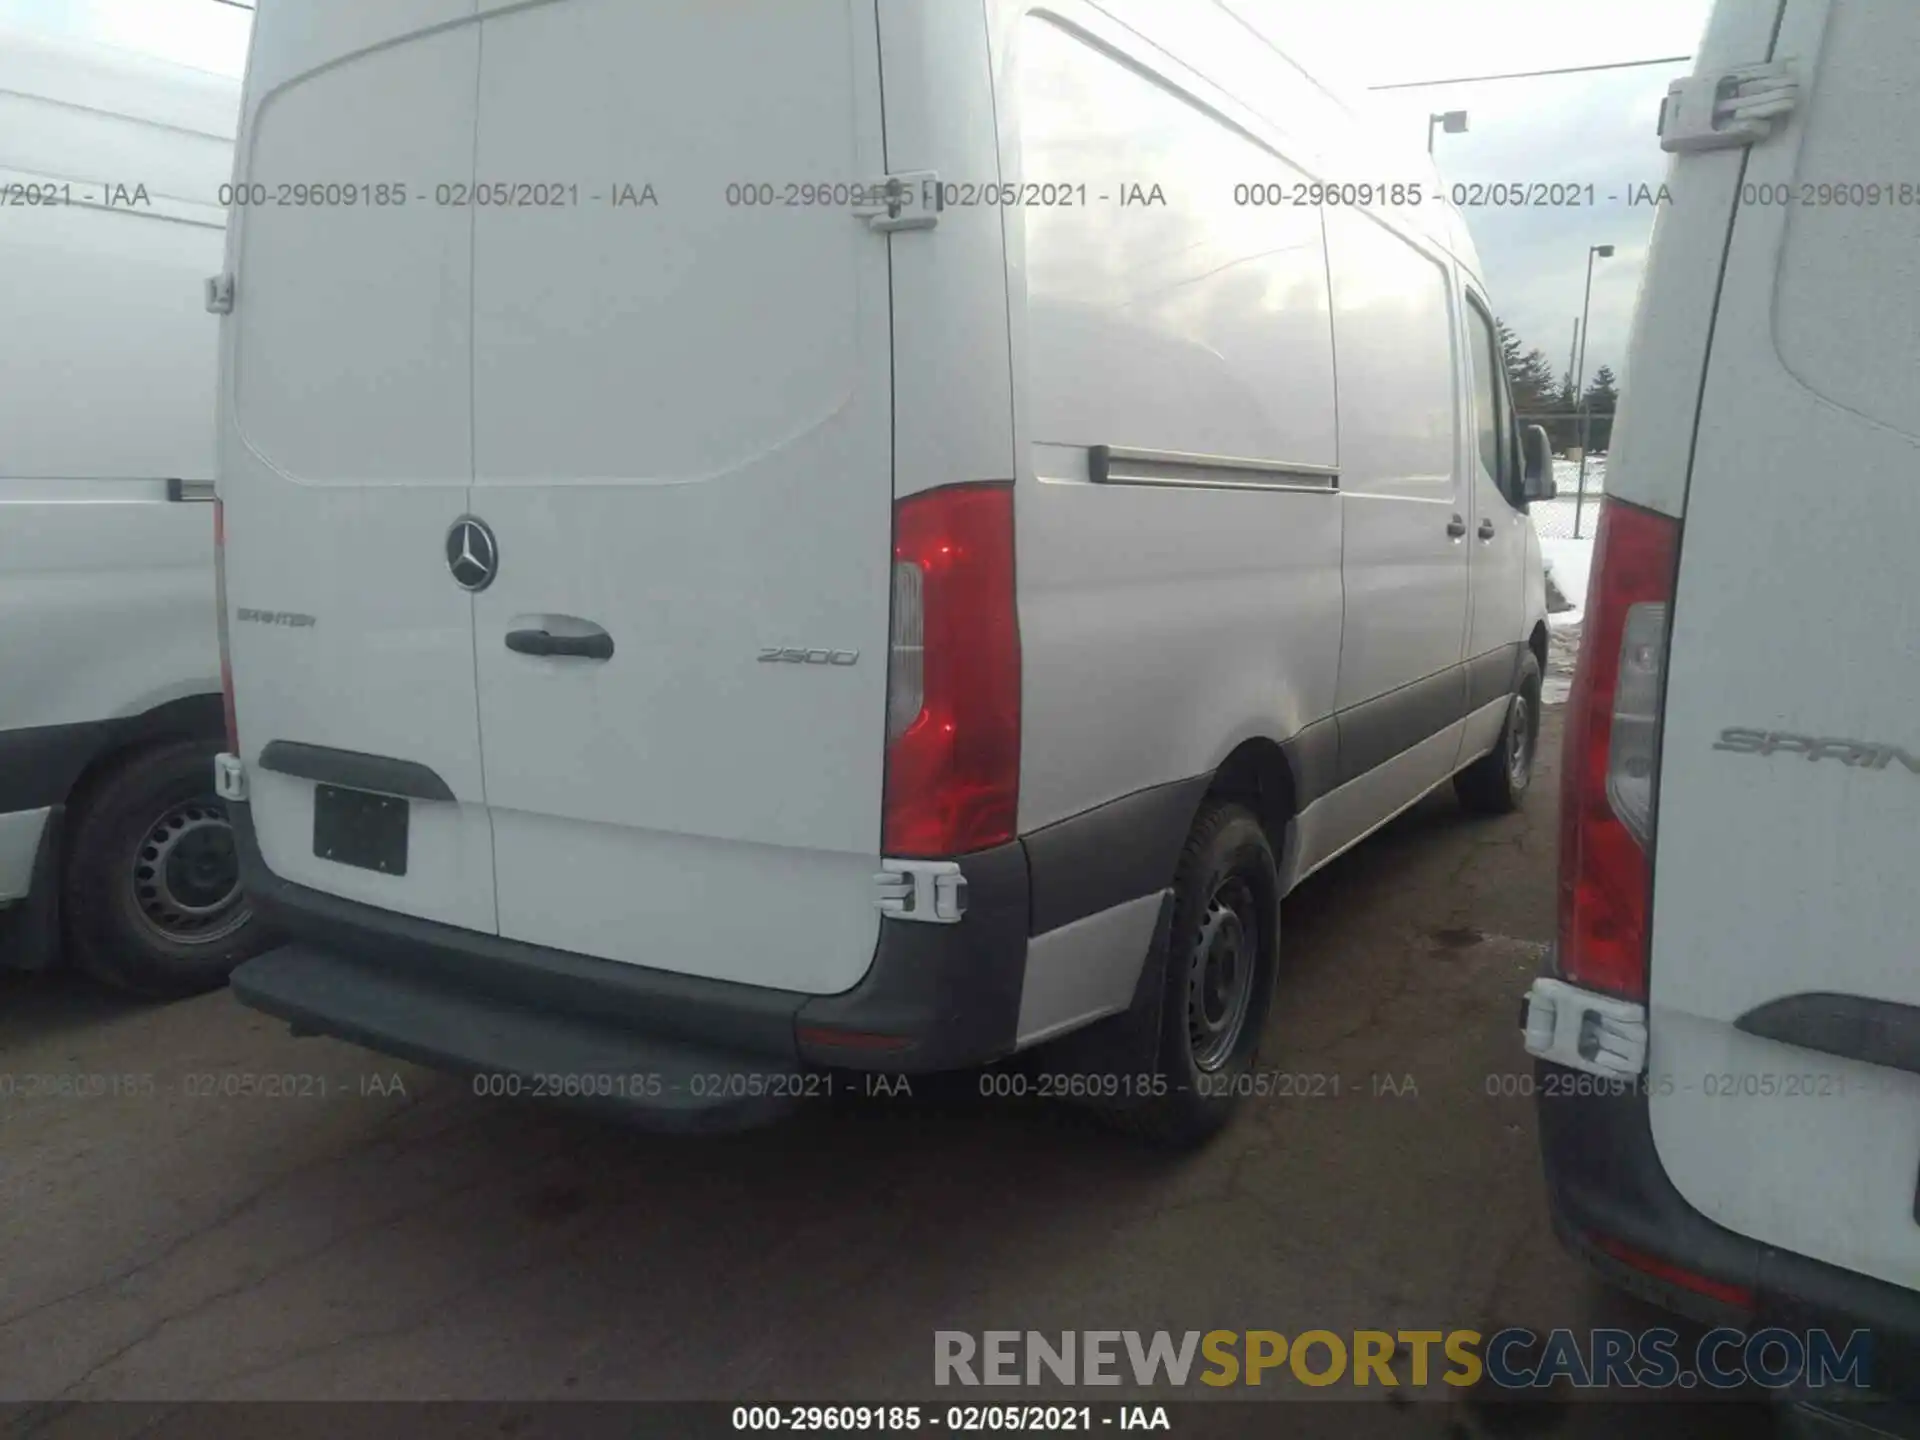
[993,0,1512,844]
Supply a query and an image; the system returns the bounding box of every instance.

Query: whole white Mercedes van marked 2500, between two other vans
[213,0,1548,1140]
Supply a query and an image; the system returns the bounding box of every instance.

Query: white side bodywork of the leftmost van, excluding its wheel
[0,29,240,904]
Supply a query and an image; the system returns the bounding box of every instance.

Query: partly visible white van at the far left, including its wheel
[0,31,261,995]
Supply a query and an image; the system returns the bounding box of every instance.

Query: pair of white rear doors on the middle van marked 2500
[228,0,894,993]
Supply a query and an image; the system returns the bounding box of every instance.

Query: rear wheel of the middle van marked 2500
[1110,801,1281,1150]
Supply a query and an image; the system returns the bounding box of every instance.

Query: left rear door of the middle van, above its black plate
[219,0,493,931]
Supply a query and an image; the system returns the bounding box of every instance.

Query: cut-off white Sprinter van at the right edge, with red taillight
[1526,0,1920,1434]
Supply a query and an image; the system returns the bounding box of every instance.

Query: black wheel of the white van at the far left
[61,739,265,1000]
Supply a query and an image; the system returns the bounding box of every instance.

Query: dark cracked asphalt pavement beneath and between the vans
[0,708,1764,1438]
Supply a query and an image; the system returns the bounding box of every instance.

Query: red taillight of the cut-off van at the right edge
[1559,499,1680,1000]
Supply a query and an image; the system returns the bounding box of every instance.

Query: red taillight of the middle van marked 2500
[881,484,1020,856]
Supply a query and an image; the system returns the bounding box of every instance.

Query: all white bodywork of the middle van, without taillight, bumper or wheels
[223,0,1544,1044]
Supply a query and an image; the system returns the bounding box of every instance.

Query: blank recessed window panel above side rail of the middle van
[1002,17,1338,468]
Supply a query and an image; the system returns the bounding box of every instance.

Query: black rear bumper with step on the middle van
[228,803,1027,1129]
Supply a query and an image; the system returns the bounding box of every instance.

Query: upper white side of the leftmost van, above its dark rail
[0,29,240,482]
